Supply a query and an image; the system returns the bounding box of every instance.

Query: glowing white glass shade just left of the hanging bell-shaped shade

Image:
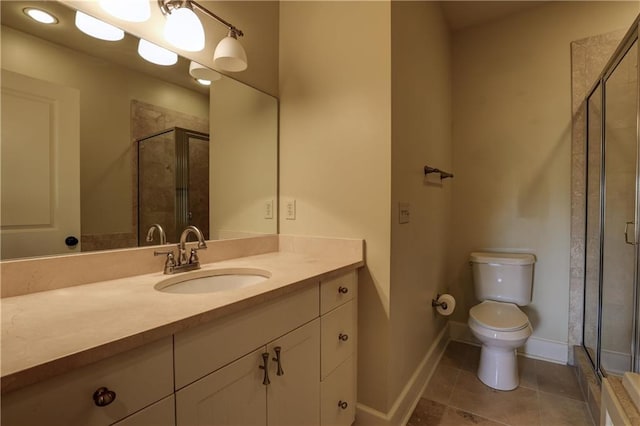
[164,7,204,52]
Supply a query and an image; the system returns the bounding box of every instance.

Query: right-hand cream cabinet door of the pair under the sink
[267,319,320,426]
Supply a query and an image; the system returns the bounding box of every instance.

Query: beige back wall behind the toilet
[449,2,638,343]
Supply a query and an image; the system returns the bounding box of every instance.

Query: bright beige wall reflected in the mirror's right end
[209,77,278,239]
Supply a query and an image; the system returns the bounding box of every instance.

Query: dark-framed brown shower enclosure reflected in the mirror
[137,127,209,246]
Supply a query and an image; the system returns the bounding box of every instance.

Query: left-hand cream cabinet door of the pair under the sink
[176,347,267,426]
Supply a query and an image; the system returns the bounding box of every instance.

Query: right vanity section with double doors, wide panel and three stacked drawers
[175,271,357,426]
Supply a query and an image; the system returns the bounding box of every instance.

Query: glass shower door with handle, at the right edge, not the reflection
[600,41,638,374]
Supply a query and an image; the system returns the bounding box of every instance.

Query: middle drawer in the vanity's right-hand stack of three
[320,301,356,380]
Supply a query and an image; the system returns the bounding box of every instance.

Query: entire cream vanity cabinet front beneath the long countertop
[1,271,357,426]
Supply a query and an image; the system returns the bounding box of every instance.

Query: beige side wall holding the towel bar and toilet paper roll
[389,2,453,408]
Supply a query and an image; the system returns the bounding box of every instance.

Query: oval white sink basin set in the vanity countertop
[154,268,271,294]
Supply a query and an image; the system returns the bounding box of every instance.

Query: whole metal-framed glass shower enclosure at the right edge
[583,21,640,376]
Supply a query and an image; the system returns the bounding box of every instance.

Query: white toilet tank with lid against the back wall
[469,252,536,306]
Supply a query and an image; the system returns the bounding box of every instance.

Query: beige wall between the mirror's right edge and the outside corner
[280,1,391,411]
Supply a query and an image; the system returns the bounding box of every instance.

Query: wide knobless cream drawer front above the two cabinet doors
[174,284,319,389]
